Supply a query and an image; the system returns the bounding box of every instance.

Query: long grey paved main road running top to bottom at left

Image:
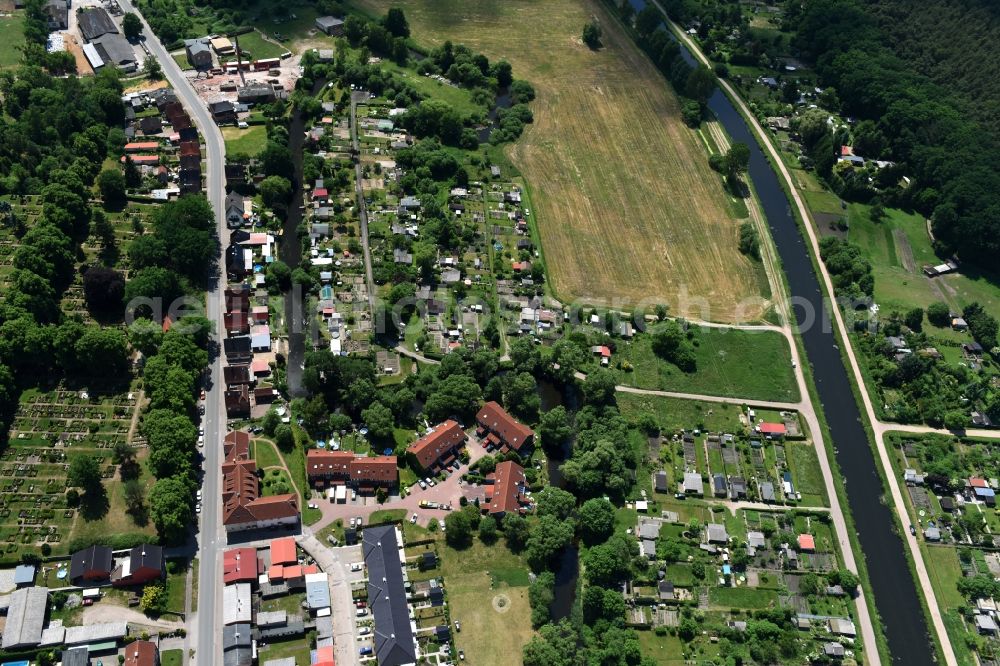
[119,0,226,666]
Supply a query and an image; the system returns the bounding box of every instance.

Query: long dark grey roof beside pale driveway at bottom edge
[362,525,417,666]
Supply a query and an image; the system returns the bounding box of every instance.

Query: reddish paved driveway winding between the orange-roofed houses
[309,437,486,534]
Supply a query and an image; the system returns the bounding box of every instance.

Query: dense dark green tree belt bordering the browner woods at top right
[786,0,1000,266]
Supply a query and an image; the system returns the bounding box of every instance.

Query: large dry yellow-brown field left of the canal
[360,0,765,321]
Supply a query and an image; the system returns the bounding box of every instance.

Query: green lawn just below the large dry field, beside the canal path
[612,328,799,400]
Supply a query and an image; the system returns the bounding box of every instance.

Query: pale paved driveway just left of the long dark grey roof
[296,535,364,666]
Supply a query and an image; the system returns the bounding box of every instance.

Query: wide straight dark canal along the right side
[631,0,934,665]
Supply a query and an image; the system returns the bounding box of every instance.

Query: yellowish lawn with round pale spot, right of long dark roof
[439,539,532,666]
